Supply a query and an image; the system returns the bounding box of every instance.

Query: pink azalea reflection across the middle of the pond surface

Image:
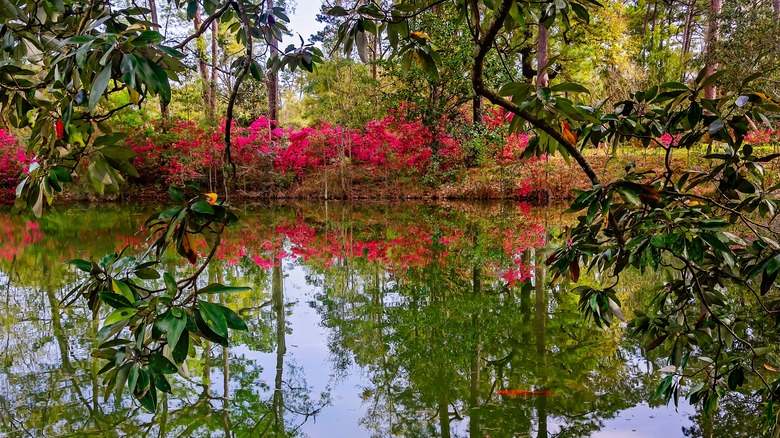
[227,209,546,287]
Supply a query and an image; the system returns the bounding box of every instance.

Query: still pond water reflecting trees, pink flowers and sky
[0,202,759,438]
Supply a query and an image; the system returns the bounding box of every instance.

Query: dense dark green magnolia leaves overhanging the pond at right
[548,76,780,424]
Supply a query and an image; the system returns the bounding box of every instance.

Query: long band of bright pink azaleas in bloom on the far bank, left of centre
[128,108,463,188]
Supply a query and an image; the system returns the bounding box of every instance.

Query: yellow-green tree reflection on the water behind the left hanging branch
[0,210,328,437]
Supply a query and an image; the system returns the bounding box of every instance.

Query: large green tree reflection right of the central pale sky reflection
[310,211,660,437]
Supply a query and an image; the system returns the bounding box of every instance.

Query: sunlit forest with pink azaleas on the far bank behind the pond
[0,0,780,204]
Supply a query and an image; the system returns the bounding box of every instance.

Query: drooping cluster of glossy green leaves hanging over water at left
[65,187,250,412]
